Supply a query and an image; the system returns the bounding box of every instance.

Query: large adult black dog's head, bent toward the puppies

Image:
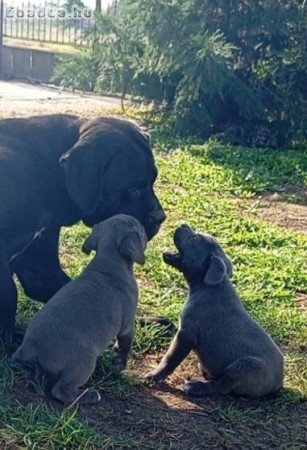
[61,117,165,239]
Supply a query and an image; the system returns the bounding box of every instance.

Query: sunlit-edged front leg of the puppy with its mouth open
[145,330,193,383]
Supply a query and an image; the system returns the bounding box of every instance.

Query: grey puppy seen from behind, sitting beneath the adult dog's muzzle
[13,215,147,404]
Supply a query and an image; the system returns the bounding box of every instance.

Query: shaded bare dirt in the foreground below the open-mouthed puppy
[84,387,307,450]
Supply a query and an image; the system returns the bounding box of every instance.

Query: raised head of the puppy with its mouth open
[163,225,233,285]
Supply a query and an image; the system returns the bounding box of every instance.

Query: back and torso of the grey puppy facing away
[13,270,131,375]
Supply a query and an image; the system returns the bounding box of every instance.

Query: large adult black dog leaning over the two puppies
[0,115,165,337]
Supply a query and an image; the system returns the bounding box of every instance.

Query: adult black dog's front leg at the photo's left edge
[0,240,17,340]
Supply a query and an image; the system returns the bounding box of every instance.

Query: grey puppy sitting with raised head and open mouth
[146,225,283,397]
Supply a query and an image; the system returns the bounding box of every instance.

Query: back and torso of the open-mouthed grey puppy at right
[186,279,283,382]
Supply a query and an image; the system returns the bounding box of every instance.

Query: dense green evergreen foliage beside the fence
[54,0,307,147]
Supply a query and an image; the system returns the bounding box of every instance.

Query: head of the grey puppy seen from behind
[82,214,147,264]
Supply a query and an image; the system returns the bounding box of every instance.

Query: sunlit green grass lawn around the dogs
[0,133,307,449]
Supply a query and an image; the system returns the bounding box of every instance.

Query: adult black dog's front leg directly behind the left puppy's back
[14,227,70,302]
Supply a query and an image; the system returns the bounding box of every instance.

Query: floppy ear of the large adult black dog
[60,142,101,214]
